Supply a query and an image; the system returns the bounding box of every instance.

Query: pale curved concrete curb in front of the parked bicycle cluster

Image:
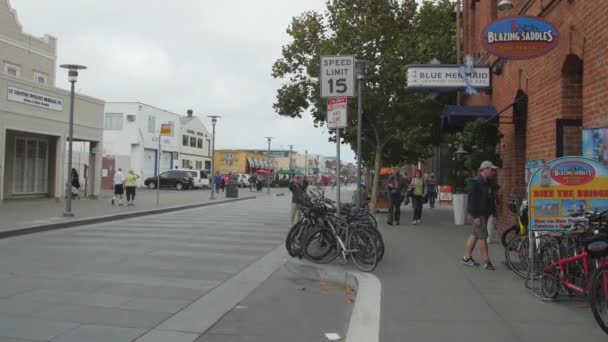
[285,259,382,342]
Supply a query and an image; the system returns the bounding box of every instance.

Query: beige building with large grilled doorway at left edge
[0,0,104,200]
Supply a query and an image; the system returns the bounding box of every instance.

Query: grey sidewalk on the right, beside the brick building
[374,206,607,342]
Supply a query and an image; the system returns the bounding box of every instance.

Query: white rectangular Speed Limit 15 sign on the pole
[320,56,355,97]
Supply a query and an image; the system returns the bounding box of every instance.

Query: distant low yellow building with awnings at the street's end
[213,150,277,174]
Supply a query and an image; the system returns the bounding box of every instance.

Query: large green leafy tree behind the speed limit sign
[272,0,455,210]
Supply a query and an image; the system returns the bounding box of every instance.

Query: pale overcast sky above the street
[10,0,354,161]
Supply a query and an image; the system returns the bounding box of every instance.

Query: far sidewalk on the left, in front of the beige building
[0,188,288,236]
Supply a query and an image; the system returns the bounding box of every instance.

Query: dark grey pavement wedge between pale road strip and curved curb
[195,265,356,342]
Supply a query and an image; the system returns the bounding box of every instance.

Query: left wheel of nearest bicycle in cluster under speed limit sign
[302,228,339,264]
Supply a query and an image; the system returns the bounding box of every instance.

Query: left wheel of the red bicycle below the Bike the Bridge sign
[538,242,561,299]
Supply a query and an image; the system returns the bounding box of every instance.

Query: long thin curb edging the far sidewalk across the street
[0,196,256,239]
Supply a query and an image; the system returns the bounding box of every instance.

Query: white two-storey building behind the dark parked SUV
[102,102,211,188]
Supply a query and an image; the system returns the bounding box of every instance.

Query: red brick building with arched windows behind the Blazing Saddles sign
[462,0,608,229]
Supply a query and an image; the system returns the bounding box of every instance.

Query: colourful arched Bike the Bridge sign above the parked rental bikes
[528,157,608,231]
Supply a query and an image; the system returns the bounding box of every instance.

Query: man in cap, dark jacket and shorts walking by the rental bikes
[462,160,498,270]
